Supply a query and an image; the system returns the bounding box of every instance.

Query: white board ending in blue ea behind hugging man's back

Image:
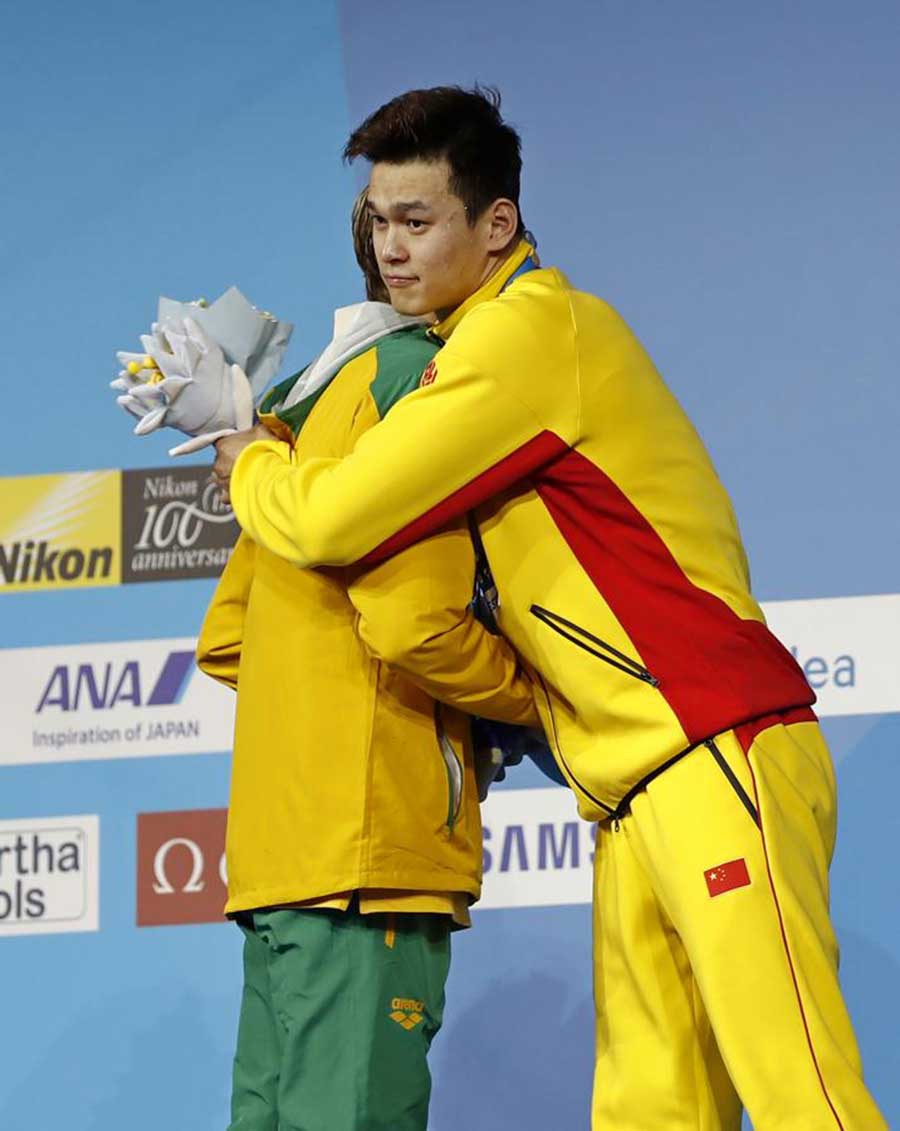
[763,593,900,718]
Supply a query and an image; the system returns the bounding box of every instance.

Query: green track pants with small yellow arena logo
[228,904,450,1131]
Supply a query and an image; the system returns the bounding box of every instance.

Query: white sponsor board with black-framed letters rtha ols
[0,815,99,939]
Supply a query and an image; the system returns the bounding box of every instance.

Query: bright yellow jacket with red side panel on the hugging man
[232,242,814,820]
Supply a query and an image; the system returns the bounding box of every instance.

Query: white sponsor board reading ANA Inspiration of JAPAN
[0,637,234,763]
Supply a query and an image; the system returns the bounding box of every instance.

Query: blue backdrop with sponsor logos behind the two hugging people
[0,0,900,1131]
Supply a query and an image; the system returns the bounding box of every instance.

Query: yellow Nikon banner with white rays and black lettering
[0,470,122,593]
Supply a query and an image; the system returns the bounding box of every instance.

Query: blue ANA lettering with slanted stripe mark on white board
[36,651,193,715]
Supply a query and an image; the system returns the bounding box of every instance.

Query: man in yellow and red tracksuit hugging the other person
[219,88,885,1131]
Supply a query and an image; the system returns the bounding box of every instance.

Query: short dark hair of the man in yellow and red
[344,85,522,232]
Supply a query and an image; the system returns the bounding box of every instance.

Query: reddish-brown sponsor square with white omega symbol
[137,809,227,926]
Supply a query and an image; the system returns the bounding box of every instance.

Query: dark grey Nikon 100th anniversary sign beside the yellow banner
[122,466,237,582]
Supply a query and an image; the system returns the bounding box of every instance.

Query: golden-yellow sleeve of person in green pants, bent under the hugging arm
[347,523,540,727]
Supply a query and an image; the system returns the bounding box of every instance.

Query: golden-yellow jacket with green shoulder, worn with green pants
[198,329,537,912]
